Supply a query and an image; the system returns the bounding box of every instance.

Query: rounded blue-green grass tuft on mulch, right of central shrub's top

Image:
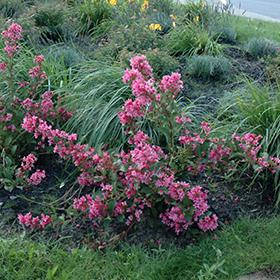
[188,55,231,80]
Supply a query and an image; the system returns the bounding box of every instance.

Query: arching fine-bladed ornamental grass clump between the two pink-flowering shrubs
[64,61,131,149]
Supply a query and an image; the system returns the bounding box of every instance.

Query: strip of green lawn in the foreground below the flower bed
[0,216,280,280]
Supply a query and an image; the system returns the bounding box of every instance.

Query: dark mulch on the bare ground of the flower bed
[0,43,274,250]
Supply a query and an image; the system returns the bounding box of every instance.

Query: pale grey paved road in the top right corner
[227,0,280,19]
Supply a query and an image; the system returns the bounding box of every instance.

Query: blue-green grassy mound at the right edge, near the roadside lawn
[245,37,280,58]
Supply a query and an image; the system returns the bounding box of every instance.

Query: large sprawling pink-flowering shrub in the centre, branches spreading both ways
[18,55,280,234]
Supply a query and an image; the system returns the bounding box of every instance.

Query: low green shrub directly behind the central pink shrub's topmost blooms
[119,49,179,79]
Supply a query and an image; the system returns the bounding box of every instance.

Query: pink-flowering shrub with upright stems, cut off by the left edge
[0,23,72,191]
